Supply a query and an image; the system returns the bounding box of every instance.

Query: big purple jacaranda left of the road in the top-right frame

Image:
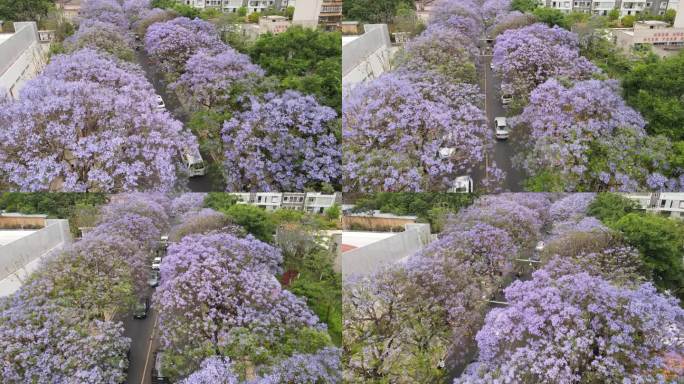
[342,72,493,192]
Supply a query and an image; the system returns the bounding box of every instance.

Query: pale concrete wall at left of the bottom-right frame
[342,224,432,278]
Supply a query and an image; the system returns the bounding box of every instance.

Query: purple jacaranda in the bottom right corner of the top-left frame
[222,91,341,191]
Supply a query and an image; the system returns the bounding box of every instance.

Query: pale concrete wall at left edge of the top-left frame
[0,22,45,98]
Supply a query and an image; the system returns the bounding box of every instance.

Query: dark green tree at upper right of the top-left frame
[249,26,342,112]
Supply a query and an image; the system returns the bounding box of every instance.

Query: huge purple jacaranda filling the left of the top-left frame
[0,50,197,192]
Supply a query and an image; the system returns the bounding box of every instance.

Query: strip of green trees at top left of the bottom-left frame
[0,192,109,235]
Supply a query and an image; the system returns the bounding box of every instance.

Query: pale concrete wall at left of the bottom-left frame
[0,219,71,280]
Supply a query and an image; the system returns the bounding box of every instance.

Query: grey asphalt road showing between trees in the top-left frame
[136,48,213,192]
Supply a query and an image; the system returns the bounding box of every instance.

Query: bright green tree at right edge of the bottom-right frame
[608,213,684,300]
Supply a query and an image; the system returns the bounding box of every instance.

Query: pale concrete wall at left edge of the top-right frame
[342,24,394,96]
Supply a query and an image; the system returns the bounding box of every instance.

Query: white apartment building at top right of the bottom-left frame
[233,192,342,213]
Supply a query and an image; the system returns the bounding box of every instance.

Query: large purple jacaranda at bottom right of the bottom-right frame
[454,270,684,383]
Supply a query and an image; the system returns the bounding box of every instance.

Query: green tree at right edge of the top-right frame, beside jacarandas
[622,51,684,140]
